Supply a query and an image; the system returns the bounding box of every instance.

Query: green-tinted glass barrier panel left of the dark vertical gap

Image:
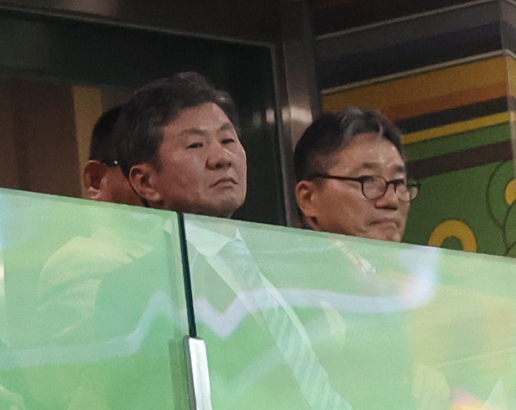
[0,190,188,410]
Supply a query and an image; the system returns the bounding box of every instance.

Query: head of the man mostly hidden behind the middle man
[83,106,142,205]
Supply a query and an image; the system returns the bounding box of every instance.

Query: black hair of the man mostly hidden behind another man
[89,105,122,166]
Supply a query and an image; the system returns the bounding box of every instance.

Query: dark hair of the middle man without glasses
[115,72,239,177]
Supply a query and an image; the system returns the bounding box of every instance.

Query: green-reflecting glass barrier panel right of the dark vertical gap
[186,216,516,410]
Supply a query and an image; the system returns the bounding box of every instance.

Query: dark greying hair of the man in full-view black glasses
[294,107,405,182]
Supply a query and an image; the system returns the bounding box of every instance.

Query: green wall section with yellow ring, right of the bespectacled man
[404,161,516,255]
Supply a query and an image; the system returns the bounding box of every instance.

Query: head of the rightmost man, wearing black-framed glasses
[294,107,419,242]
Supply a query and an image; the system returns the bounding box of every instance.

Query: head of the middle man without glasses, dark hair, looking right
[115,72,247,217]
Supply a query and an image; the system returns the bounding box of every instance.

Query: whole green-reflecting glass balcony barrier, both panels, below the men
[0,190,516,410]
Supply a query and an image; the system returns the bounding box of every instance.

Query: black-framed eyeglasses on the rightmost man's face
[308,174,421,202]
